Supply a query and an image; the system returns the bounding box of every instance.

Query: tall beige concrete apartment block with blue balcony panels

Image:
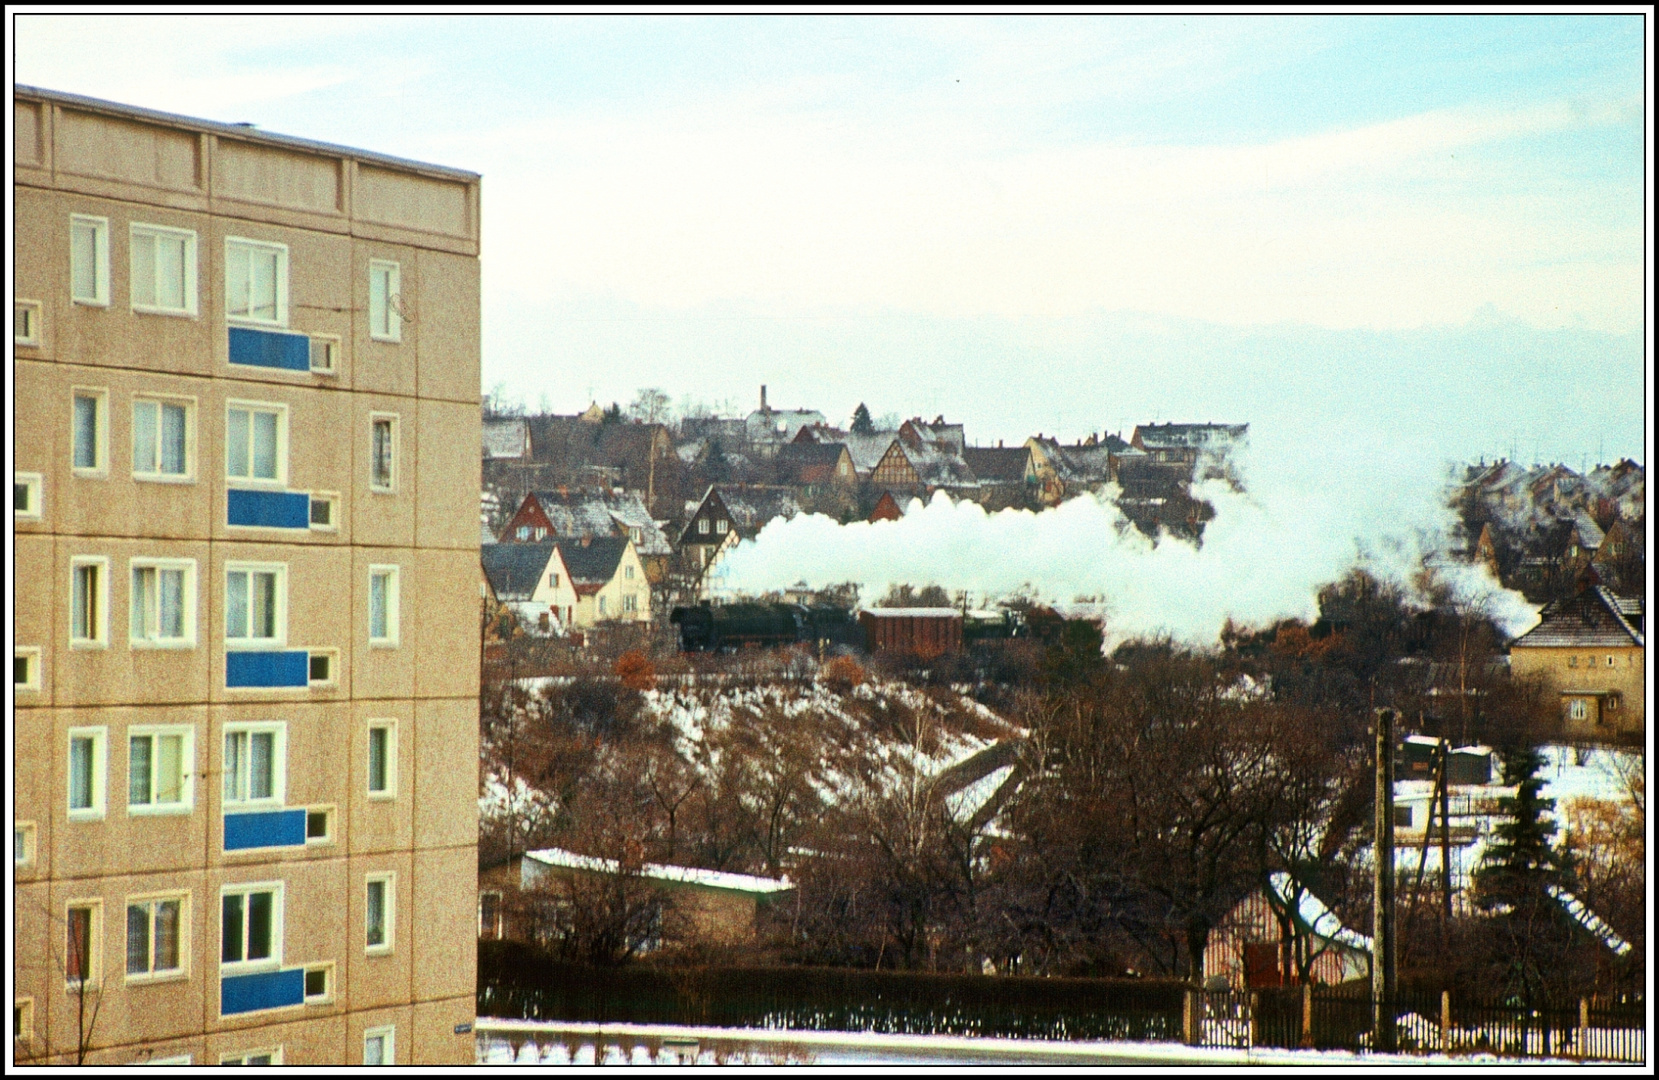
[12,88,479,1065]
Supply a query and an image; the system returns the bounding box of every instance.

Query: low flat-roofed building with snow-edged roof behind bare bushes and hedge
[478,848,793,952]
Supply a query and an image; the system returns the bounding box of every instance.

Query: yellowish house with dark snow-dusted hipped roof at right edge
[1510,576,1646,738]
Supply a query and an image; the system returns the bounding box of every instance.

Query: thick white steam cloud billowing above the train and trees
[720,430,1538,647]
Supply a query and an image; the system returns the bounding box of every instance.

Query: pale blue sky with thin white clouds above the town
[13,13,1649,468]
